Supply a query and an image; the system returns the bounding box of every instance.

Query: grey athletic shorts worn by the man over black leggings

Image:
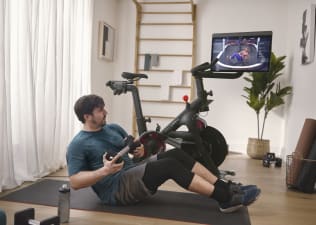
[115,155,157,205]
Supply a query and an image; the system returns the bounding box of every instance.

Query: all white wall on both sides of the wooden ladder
[92,0,316,155]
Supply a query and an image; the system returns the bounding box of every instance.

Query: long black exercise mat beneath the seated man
[0,179,251,225]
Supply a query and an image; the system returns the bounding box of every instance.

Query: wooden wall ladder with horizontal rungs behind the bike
[133,0,196,135]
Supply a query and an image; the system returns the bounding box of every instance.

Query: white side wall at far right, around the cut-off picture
[282,0,316,155]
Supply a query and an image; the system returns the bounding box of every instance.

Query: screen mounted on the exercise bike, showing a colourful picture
[211,31,272,72]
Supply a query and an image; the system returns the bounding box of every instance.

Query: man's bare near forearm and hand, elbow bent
[69,156,124,190]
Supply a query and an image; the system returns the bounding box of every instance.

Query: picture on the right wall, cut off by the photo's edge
[300,4,316,65]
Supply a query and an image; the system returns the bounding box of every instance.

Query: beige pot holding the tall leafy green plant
[247,138,270,159]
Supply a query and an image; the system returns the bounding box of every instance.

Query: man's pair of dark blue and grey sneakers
[219,187,261,213]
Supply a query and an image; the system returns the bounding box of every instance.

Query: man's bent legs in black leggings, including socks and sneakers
[143,158,260,212]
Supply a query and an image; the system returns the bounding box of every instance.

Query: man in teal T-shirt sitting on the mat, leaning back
[67,95,260,212]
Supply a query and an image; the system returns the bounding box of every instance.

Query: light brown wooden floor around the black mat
[0,154,316,225]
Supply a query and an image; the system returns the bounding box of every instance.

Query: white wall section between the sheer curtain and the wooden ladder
[91,0,136,132]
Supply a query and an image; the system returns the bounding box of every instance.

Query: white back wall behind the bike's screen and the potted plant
[196,0,287,153]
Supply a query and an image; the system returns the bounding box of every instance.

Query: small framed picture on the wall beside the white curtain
[99,21,115,61]
